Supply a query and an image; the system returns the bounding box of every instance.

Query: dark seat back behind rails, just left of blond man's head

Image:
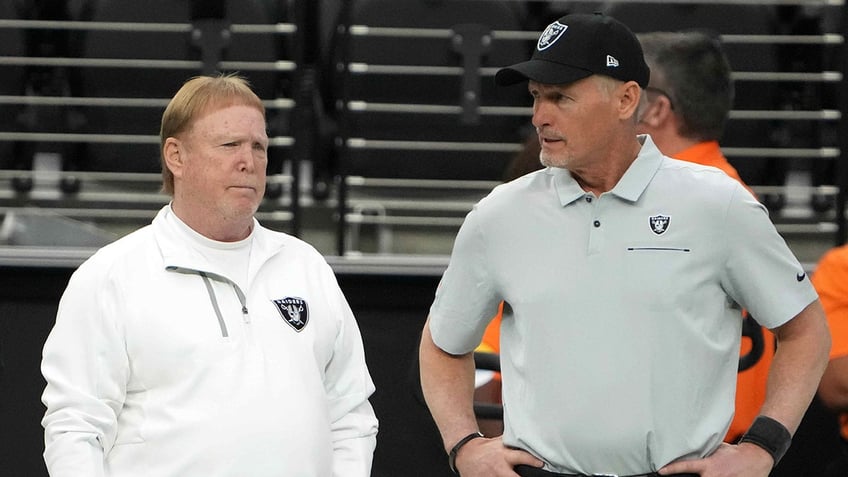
[83,0,190,173]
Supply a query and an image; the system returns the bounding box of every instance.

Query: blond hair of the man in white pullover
[159,73,265,195]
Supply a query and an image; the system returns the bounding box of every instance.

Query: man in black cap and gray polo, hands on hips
[420,14,830,477]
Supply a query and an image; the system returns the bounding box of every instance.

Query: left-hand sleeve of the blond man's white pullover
[41,264,128,477]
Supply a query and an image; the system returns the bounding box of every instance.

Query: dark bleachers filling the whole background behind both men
[0,0,846,255]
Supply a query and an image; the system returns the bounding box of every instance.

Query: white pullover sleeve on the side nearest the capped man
[324,267,378,477]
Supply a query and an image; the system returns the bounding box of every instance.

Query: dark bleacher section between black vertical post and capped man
[330,0,532,255]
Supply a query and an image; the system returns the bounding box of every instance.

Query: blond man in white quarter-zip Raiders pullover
[42,75,377,477]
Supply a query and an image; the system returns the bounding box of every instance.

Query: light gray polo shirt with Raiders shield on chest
[430,136,816,475]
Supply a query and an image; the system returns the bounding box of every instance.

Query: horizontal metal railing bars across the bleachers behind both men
[0,0,848,262]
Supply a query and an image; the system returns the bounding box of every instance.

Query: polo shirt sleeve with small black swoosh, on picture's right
[722,185,817,329]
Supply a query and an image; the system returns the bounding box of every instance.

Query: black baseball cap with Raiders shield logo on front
[495,13,651,88]
